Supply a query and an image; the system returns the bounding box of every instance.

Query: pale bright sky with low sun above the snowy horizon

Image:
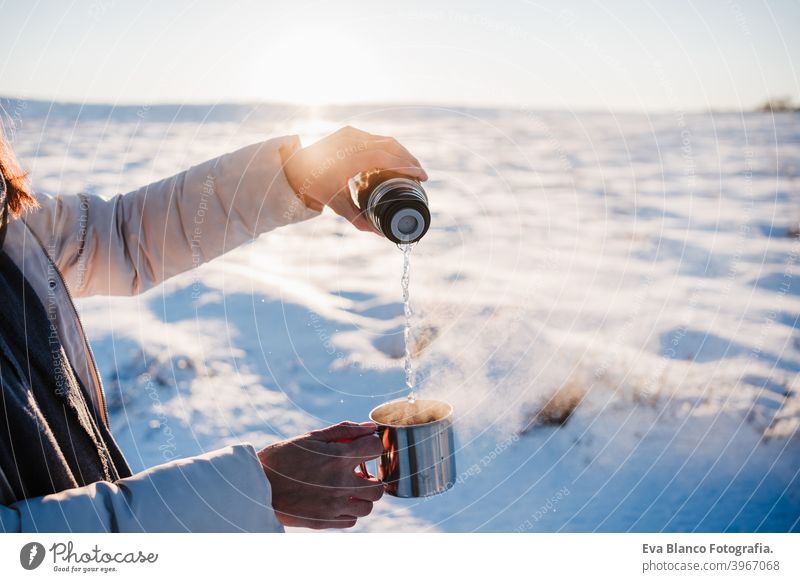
[0,0,800,110]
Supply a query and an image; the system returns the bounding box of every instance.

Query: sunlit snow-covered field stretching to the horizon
[4,101,800,531]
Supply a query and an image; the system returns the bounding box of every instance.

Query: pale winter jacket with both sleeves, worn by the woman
[0,136,319,532]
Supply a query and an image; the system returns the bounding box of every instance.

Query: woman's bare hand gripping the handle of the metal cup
[258,421,383,529]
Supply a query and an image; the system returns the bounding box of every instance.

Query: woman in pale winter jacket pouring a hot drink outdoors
[0,127,427,532]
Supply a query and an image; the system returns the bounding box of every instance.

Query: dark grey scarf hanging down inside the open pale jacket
[0,188,130,505]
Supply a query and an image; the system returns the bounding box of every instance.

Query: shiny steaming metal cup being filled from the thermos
[369,398,456,497]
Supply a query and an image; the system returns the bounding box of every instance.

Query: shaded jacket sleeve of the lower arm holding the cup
[0,444,284,533]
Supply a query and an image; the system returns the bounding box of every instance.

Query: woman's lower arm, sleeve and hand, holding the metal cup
[0,421,383,532]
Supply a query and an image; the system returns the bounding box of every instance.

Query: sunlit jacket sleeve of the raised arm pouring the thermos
[19,136,320,296]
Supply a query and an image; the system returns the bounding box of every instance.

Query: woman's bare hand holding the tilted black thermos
[283,127,428,232]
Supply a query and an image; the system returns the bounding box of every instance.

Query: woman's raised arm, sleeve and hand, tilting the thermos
[25,127,427,296]
